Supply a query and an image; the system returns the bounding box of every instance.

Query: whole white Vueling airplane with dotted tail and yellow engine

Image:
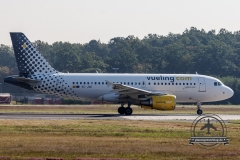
[4,32,234,115]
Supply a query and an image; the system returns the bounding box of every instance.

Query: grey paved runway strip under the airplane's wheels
[0,113,240,121]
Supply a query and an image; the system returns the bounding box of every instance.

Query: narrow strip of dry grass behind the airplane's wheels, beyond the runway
[0,105,240,114]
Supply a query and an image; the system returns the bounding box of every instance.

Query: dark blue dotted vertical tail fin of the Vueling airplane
[10,32,58,77]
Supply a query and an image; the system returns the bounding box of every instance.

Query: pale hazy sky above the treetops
[0,0,240,45]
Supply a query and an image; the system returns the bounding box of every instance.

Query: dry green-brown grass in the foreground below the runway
[0,120,240,160]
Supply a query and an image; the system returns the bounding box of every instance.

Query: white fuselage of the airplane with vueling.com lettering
[36,73,233,102]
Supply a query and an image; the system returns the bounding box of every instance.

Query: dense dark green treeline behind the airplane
[0,27,240,104]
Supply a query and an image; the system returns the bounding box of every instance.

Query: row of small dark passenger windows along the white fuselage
[73,82,196,86]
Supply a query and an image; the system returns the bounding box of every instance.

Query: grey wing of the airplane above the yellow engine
[107,81,165,98]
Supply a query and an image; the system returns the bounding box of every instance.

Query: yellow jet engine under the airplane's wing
[141,95,176,110]
